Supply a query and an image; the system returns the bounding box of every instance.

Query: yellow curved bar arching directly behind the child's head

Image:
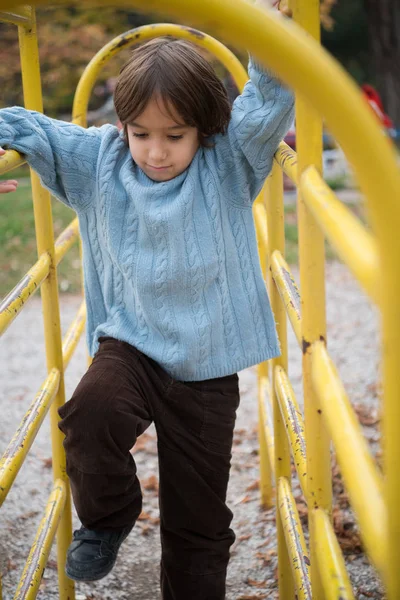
[72,23,248,127]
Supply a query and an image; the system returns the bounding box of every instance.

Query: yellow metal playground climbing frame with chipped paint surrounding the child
[0,0,400,600]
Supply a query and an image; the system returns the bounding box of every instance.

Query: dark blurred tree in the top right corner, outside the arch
[321,0,400,127]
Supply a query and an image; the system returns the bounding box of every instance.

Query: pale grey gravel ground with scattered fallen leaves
[0,263,384,600]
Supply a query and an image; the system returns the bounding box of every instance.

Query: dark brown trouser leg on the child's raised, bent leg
[59,338,152,529]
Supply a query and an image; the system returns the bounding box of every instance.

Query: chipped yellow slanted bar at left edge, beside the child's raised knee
[0,369,60,506]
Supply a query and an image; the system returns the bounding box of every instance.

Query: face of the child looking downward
[127,97,199,181]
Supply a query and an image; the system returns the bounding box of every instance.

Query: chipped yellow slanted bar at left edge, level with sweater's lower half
[0,252,51,336]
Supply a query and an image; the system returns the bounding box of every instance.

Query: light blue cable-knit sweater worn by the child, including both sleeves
[0,62,293,381]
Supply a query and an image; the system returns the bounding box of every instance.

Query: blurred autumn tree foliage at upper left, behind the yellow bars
[0,7,149,116]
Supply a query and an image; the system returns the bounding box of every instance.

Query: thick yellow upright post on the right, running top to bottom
[293,0,332,600]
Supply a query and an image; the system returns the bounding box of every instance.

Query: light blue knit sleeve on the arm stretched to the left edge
[0,107,107,211]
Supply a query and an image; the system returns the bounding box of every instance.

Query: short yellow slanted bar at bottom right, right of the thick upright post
[314,508,354,600]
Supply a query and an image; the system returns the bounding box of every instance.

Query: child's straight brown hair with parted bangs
[114,37,231,146]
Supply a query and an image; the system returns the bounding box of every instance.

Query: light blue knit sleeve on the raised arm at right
[212,59,294,204]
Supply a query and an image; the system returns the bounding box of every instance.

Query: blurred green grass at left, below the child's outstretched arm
[0,178,81,297]
